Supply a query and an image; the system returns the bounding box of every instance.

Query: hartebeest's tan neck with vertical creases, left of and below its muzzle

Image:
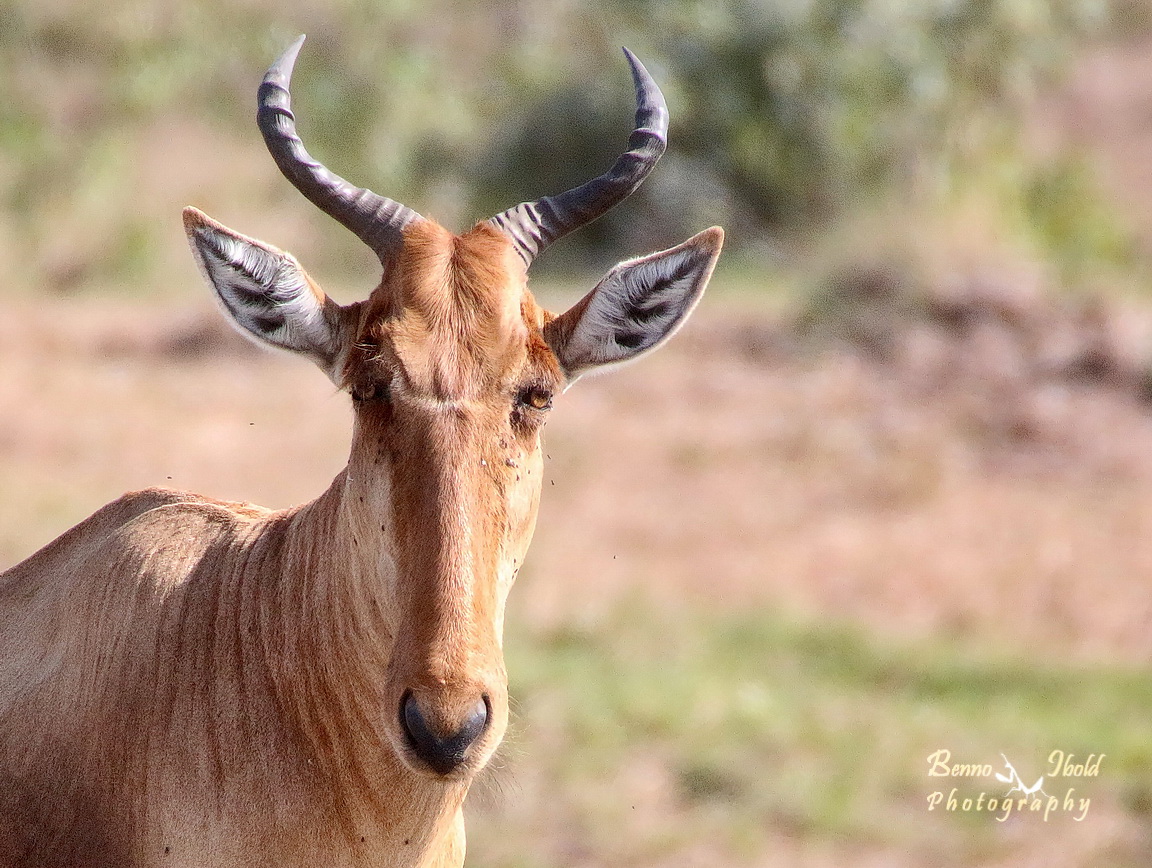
[262,469,468,847]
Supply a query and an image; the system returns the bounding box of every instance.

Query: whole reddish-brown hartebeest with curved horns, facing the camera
[0,37,723,868]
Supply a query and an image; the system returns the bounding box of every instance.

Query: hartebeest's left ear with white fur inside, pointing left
[184,207,341,377]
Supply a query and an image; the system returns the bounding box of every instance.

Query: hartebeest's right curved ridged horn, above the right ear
[490,48,668,265]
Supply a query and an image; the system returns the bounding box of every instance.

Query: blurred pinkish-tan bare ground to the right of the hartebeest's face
[520,281,1152,661]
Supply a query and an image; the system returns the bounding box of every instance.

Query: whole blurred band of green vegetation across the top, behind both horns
[0,0,1132,292]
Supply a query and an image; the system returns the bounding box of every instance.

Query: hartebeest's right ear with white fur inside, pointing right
[544,226,723,382]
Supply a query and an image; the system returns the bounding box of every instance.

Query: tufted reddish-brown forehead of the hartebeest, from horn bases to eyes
[364,220,536,399]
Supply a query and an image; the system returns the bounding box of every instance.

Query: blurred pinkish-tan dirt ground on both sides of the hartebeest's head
[0,279,1152,662]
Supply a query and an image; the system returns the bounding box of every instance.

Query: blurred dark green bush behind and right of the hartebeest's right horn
[442,0,1108,265]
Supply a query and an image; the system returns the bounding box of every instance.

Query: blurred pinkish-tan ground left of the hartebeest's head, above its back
[0,302,348,555]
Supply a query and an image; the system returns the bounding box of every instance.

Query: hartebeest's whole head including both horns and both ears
[184,37,723,780]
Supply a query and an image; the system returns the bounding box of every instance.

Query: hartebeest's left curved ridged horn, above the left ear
[256,36,420,262]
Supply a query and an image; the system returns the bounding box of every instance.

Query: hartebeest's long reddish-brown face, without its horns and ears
[343,221,555,777]
